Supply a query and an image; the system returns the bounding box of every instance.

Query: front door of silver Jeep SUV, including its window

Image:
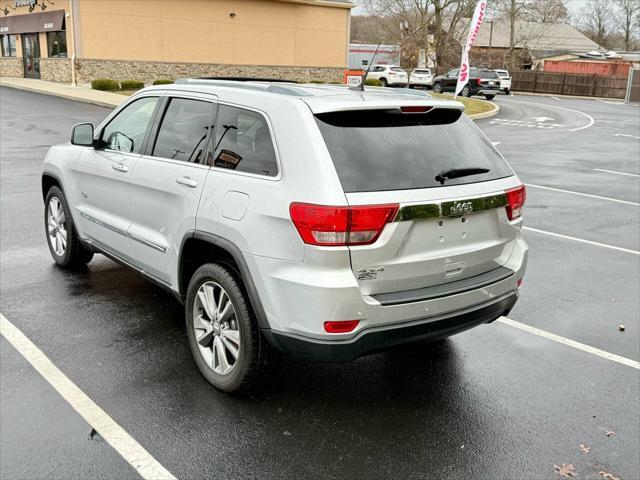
[73,97,158,261]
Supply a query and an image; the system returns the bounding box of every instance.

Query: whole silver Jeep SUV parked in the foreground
[42,80,527,391]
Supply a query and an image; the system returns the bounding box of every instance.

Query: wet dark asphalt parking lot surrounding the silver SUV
[0,88,640,480]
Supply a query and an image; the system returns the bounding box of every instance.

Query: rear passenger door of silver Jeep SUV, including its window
[129,97,216,285]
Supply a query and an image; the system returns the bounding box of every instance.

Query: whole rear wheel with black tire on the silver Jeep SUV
[185,263,275,392]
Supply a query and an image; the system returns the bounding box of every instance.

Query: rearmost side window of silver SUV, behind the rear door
[213,105,278,177]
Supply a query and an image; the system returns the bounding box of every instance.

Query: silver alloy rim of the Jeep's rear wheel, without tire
[192,281,241,375]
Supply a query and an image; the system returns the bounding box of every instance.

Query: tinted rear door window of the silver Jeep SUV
[152,98,213,162]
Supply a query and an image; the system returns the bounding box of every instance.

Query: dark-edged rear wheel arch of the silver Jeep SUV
[177,230,270,329]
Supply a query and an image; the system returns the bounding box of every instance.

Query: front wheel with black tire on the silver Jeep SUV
[44,187,93,269]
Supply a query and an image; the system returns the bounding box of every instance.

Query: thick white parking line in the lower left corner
[0,314,176,480]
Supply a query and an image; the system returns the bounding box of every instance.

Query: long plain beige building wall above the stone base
[75,0,349,67]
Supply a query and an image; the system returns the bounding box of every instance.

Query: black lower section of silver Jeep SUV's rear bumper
[263,291,518,362]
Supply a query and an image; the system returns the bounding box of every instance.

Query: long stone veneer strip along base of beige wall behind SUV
[76,59,344,84]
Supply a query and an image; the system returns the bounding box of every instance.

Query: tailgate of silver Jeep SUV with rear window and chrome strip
[316,102,520,295]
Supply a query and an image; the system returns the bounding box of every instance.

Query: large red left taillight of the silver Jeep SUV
[289,203,398,247]
